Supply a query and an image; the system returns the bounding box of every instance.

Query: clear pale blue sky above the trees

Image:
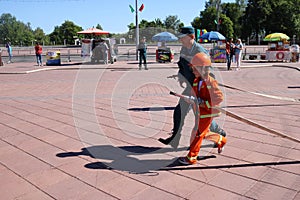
[0,0,235,34]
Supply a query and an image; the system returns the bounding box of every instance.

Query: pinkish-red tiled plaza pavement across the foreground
[0,60,300,200]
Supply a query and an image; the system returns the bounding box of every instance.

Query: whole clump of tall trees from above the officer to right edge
[196,0,300,41]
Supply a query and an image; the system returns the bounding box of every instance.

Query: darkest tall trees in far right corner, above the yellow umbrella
[242,0,300,41]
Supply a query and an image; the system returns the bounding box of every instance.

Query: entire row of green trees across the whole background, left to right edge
[0,0,300,46]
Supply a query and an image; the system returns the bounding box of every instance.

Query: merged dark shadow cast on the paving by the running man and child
[56,145,215,174]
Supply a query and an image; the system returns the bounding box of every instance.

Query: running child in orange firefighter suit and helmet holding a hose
[179,52,226,165]
